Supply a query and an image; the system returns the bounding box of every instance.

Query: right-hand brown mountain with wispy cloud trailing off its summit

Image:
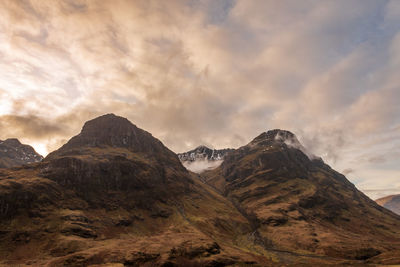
[203,130,400,262]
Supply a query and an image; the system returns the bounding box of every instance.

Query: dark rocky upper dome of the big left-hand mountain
[40,114,191,205]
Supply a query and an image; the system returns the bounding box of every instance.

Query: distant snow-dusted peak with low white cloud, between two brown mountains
[178,146,234,173]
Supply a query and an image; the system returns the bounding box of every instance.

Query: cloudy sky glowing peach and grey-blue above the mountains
[0,0,400,198]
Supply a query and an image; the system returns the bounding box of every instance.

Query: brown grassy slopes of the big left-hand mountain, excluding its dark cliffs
[0,148,268,266]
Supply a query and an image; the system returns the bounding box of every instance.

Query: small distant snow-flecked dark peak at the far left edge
[0,138,43,168]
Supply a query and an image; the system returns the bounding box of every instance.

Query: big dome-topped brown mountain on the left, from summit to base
[0,114,269,266]
